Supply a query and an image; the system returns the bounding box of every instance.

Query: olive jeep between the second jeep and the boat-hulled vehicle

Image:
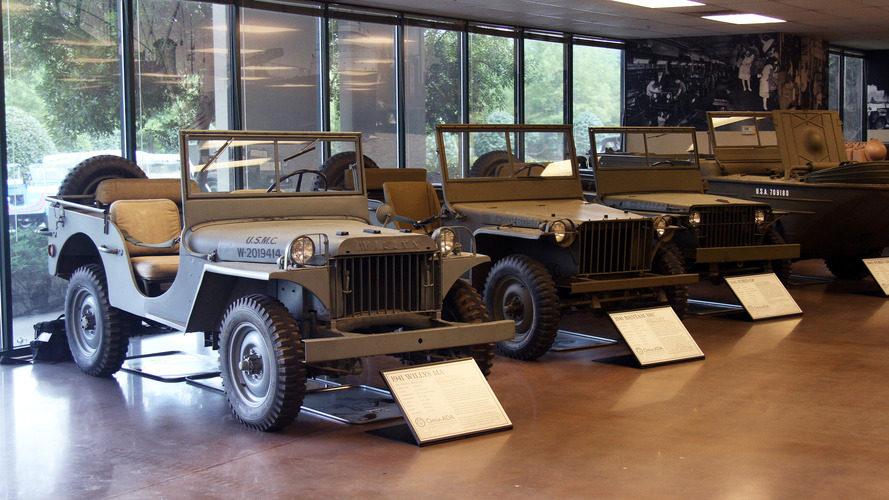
[582,127,799,283]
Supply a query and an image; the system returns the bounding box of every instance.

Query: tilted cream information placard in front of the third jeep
[725,273,803,321]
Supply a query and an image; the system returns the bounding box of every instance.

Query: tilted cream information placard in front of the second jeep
[608,306,704,366]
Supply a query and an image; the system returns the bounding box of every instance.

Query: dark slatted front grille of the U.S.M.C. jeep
[331,252,441,318]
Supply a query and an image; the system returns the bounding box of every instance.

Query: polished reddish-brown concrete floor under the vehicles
[0,261,889,499]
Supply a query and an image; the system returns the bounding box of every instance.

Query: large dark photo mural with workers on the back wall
[624,33,827,130]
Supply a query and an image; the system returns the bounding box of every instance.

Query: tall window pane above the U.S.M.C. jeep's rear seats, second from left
[134,0,231,168]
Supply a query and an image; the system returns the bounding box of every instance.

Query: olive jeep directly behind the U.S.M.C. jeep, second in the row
[377,125,698,360]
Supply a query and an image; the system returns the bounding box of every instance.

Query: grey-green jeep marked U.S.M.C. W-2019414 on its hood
[43,130,513,431]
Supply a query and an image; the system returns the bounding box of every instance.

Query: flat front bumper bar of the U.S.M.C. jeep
[303,320,515,363]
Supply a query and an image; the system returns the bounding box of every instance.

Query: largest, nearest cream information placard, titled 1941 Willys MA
[380,358,512,446]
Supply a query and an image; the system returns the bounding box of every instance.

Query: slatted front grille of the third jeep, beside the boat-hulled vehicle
[692,205,757,248]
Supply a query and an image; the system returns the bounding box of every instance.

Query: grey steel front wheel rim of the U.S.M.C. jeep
[228,323,274,407]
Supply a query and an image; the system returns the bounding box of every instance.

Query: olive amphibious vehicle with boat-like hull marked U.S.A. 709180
[701,111,889,259]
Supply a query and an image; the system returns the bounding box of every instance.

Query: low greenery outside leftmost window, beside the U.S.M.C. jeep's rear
[9,229,66,316]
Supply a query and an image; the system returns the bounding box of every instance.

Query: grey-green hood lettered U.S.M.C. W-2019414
[184,219,437,263]
